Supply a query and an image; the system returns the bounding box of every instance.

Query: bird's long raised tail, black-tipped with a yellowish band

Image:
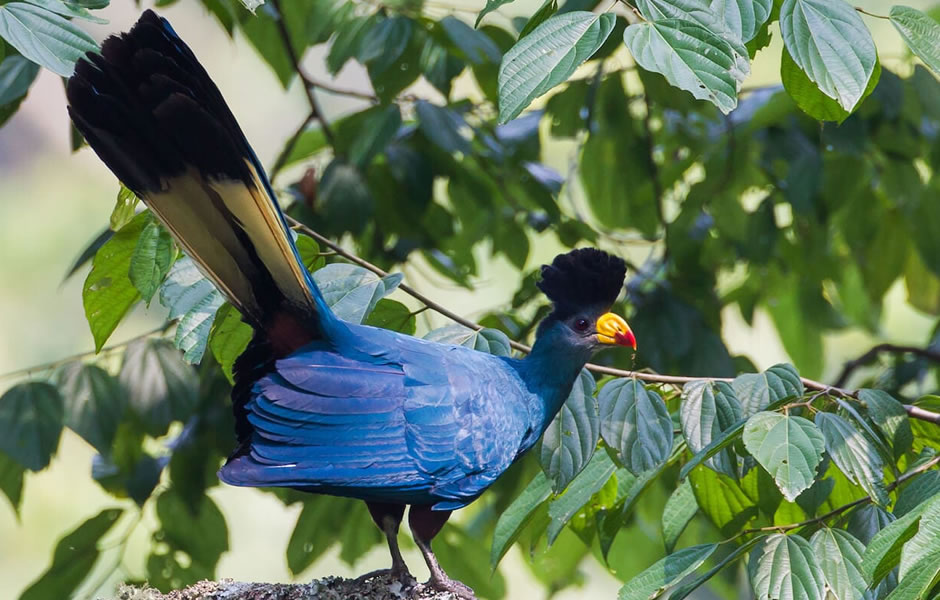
[67,10,336,351]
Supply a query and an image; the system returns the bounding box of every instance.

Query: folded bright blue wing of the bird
[220,328,528,508]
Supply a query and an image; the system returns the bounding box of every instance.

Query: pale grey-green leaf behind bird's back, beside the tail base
[313,263,402,324]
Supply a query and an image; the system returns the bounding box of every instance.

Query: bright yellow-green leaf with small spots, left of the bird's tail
[82,212,151,352]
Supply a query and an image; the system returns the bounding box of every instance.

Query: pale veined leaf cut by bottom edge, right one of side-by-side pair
[809,527,868,600]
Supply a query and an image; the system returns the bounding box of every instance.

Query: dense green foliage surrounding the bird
[0,0,940,600]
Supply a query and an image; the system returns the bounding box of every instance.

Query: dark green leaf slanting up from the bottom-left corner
[20,508,124,600]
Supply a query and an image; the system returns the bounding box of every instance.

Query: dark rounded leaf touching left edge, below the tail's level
[0,381,65,471]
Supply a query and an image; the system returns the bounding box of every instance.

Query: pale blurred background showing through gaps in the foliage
[0,0,932,599]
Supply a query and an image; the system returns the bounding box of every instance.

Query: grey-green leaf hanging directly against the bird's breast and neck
[539,369,600,492]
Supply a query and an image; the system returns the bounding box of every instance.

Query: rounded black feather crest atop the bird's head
[536,248,627,319]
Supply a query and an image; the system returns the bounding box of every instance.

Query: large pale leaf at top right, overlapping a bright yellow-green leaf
[780,0,878,111]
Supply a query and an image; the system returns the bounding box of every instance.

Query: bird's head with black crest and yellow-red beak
[536,248,636,352]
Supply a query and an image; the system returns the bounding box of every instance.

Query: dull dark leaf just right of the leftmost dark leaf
[58,362,124,454]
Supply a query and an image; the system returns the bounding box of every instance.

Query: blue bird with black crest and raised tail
[66,10,636,598]
